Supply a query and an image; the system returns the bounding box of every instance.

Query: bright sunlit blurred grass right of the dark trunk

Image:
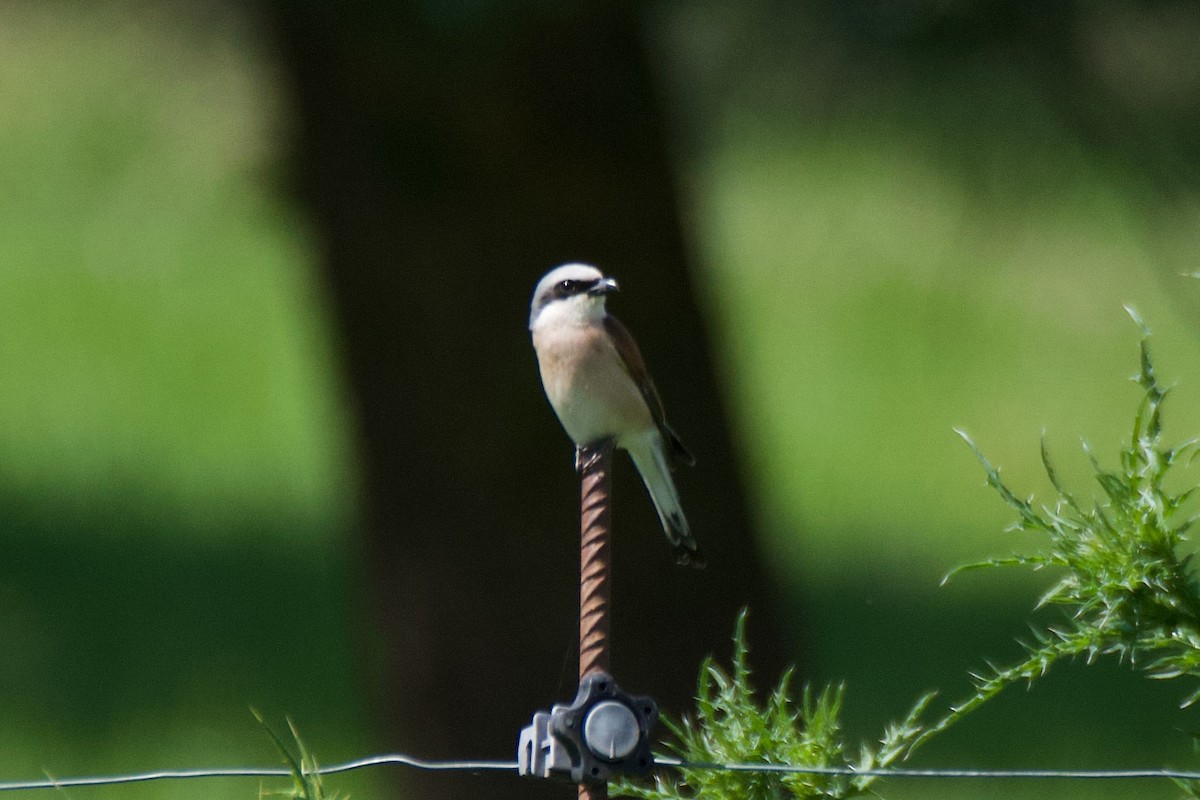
[697,121,1200,581]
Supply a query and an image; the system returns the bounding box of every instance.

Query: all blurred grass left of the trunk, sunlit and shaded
[0,0,380,799]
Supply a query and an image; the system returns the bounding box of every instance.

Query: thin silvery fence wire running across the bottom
[0,753,1200,792]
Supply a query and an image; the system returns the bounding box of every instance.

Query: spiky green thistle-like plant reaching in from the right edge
[925,312,1200,736]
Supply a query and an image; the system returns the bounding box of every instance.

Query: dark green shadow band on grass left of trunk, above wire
[0,504,364,758]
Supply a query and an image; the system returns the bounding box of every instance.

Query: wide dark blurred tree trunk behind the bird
[259,0,790,798]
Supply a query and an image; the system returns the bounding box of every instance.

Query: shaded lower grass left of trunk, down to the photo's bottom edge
[0,532,382,798]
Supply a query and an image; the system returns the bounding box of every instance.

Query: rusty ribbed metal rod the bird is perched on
[578,440,613,800]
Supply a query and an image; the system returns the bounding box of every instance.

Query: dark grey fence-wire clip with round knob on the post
[517,672,659,784]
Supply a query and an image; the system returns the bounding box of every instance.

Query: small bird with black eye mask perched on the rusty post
[529,264,704,567]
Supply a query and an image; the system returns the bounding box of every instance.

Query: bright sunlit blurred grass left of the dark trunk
[0,2,348,539]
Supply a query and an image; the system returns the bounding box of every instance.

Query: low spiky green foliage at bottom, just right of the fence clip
[612,610,932,800]
